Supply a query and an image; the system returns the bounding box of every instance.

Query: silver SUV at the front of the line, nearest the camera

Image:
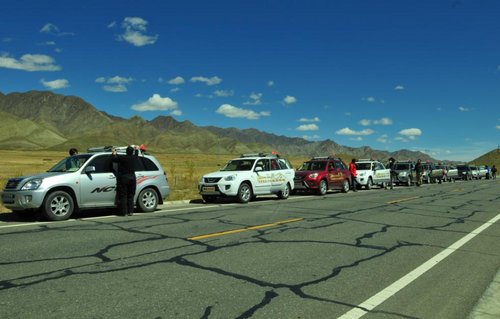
[1,146,170,220]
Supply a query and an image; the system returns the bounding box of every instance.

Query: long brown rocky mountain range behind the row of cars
[0,91,433,161]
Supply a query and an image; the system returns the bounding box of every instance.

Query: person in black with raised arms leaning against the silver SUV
[112,146,137,216]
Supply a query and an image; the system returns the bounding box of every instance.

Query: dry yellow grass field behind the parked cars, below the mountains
[0,150,307,212]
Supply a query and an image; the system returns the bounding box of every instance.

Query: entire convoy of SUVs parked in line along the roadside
[1,146,489,220]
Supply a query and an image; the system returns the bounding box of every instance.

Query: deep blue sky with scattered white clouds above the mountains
[0,0,500,160]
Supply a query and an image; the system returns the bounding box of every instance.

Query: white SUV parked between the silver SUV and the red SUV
[198,153,295,203]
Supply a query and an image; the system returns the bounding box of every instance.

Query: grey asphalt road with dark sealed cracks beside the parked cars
[0,180,500,319]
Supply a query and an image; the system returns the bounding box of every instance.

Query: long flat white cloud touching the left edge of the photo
[0,54,61,72]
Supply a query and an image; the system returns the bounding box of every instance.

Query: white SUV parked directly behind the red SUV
[356,160,391,189]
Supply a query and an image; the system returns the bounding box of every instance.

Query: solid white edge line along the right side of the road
[338,214,500,319]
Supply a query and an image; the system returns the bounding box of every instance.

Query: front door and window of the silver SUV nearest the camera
[79,154,116,207]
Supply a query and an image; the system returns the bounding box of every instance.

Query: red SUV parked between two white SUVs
[294,156,351,195]
